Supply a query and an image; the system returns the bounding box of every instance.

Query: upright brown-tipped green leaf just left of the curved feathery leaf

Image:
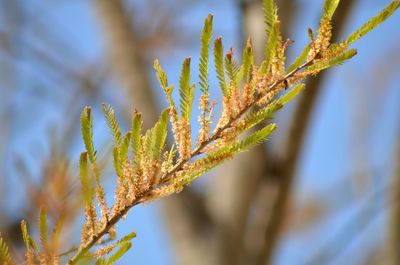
[81,107,96,163]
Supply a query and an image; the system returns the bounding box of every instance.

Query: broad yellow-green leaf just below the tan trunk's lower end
[144,109,169,160]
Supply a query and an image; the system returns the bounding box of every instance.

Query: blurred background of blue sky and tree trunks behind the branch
[0,0,400,265]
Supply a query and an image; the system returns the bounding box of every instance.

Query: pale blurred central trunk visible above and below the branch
[206,0,296,264]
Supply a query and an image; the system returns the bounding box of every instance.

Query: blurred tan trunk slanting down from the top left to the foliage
[94,0,159,128]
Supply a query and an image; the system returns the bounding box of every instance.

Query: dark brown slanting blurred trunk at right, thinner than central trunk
[253,1,357,265]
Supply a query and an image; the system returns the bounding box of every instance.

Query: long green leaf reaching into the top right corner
[344,0,400,46]
